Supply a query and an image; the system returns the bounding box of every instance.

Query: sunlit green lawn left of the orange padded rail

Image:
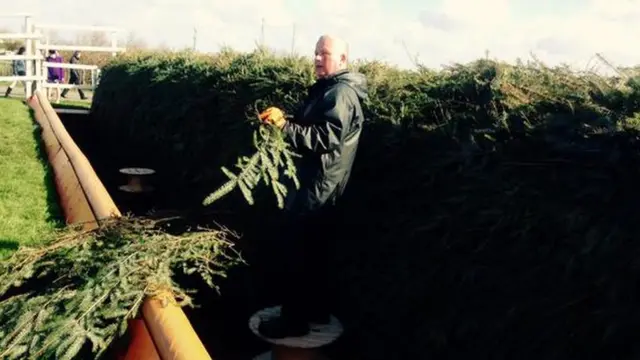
[0,98,63,257]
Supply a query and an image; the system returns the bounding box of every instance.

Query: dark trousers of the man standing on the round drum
[279,206,340,322]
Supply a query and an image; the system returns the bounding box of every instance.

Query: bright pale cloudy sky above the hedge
[0,0,640,69]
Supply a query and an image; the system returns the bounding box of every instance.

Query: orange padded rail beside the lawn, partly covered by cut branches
[28,90,211,360]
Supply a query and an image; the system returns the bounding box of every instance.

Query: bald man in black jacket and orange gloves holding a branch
[259,35,367,339]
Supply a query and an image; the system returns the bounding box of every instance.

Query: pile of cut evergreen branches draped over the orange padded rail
[0,218,240,359]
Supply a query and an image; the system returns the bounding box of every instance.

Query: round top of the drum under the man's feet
[249,306,343,349]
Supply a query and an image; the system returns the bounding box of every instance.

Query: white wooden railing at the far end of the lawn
[0,14,126,98]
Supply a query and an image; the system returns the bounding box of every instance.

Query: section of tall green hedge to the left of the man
[92,49,312,207]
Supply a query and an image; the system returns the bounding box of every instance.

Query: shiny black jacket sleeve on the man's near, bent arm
[283,86,352,154]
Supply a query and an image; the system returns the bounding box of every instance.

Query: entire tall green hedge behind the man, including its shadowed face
[92,51,640,359]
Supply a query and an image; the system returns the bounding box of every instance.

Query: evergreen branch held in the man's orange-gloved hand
[203,118,300,209]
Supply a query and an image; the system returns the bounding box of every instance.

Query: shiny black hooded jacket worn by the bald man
[283,70,367,213]
